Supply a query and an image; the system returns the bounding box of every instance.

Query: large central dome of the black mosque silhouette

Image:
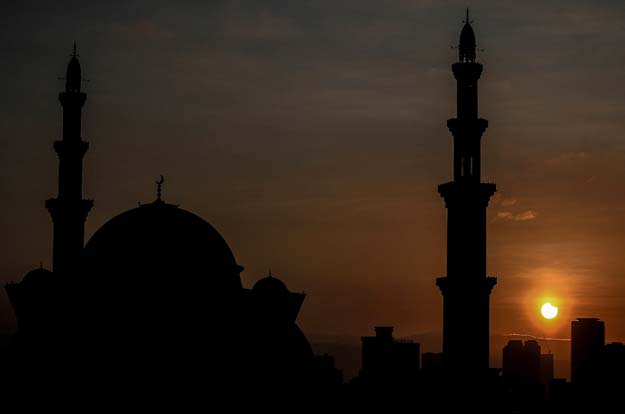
[84,198,243,294]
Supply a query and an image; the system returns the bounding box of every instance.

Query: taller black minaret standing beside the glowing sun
[436,9,497,374]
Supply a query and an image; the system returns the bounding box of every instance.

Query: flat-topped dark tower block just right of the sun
[571,318,605,385]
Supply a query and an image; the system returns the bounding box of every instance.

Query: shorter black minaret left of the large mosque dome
[46,44,93,273]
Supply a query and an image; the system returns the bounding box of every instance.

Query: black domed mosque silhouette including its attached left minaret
[5,49,322,399]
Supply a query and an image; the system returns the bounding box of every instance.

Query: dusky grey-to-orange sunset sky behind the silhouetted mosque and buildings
[0,0,625,366]
